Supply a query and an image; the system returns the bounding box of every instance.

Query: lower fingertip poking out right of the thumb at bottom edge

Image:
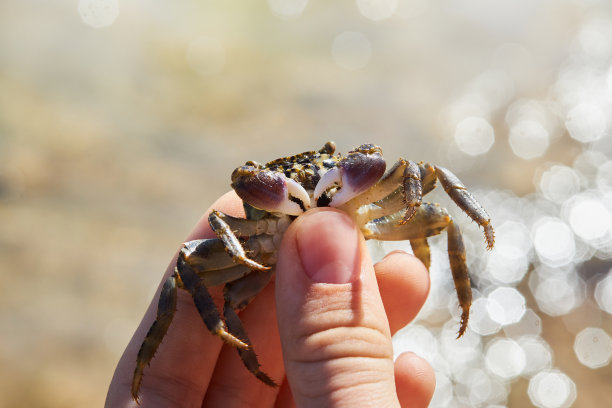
[395,353,436,408]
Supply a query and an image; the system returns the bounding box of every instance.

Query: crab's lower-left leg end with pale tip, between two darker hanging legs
[177,252,250,348]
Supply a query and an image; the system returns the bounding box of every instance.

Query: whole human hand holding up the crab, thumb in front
[106,192,435,408]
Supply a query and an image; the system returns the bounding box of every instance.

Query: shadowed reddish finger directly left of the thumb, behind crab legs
[202,283,285,408]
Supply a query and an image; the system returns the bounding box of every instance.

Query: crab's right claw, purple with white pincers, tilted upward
[314,144,387,207]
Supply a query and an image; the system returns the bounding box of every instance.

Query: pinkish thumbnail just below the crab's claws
[296,210,360,283]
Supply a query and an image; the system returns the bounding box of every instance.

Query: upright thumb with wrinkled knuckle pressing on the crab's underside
[275,208,399,407]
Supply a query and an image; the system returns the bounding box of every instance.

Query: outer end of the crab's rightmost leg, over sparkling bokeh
[435,166,495,249]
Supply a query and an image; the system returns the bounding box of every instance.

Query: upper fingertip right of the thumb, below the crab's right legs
[374,251,430,334]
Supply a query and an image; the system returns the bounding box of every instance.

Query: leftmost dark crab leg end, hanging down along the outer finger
[132,272,177,403]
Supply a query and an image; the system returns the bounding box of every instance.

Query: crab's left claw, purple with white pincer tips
[232,165,310,215]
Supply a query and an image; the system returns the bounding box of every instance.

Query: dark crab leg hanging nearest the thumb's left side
[223,271,277,387]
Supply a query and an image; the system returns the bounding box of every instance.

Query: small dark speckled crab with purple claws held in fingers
[131,142,495,402]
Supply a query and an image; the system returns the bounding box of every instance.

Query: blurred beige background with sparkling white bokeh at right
[0,0,612,408]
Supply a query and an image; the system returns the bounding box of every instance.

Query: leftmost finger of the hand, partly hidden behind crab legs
[106,192,243,407]
